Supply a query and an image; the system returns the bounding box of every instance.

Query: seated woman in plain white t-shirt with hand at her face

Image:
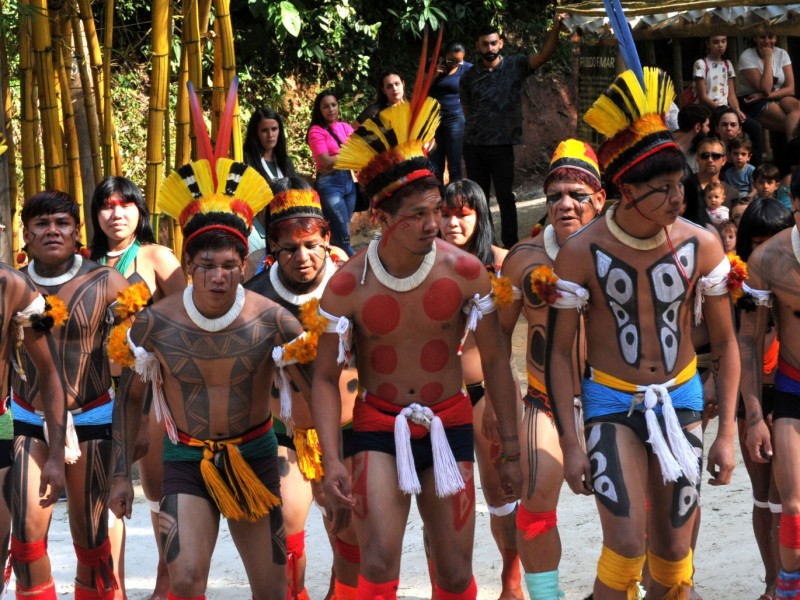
[739,33,800,138]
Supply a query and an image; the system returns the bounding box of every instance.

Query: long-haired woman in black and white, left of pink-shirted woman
[243,106,297,252]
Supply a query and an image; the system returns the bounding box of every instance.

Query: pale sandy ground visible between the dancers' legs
[37,189,764,600]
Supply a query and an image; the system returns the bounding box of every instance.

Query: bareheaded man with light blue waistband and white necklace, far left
[11,191,128,600]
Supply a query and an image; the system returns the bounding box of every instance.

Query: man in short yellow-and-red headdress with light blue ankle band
[500,139,606,600]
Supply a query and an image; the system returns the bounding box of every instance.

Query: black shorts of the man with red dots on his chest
[353,423,475,473]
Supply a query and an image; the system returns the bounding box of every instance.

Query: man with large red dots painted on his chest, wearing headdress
[312,62,521,600]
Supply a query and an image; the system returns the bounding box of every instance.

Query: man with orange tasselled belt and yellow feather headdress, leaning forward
[109,145,310,600]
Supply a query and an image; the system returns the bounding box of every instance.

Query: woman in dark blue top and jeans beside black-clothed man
[429,42,472,185]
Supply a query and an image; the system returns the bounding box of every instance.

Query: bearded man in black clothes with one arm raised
[460,15,563,249]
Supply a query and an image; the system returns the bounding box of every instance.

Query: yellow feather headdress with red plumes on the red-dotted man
[336,30,442,208]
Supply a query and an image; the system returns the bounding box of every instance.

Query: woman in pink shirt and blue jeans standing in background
[306,89,356,256]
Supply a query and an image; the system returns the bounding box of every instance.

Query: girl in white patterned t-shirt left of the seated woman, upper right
[694,35,764,165]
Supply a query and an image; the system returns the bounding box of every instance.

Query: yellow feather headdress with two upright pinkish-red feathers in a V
[158,78,272,251]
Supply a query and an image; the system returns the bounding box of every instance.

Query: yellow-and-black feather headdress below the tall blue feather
[583,67,677,183]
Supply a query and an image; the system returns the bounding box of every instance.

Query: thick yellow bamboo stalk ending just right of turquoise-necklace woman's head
[144,0,169,214]
